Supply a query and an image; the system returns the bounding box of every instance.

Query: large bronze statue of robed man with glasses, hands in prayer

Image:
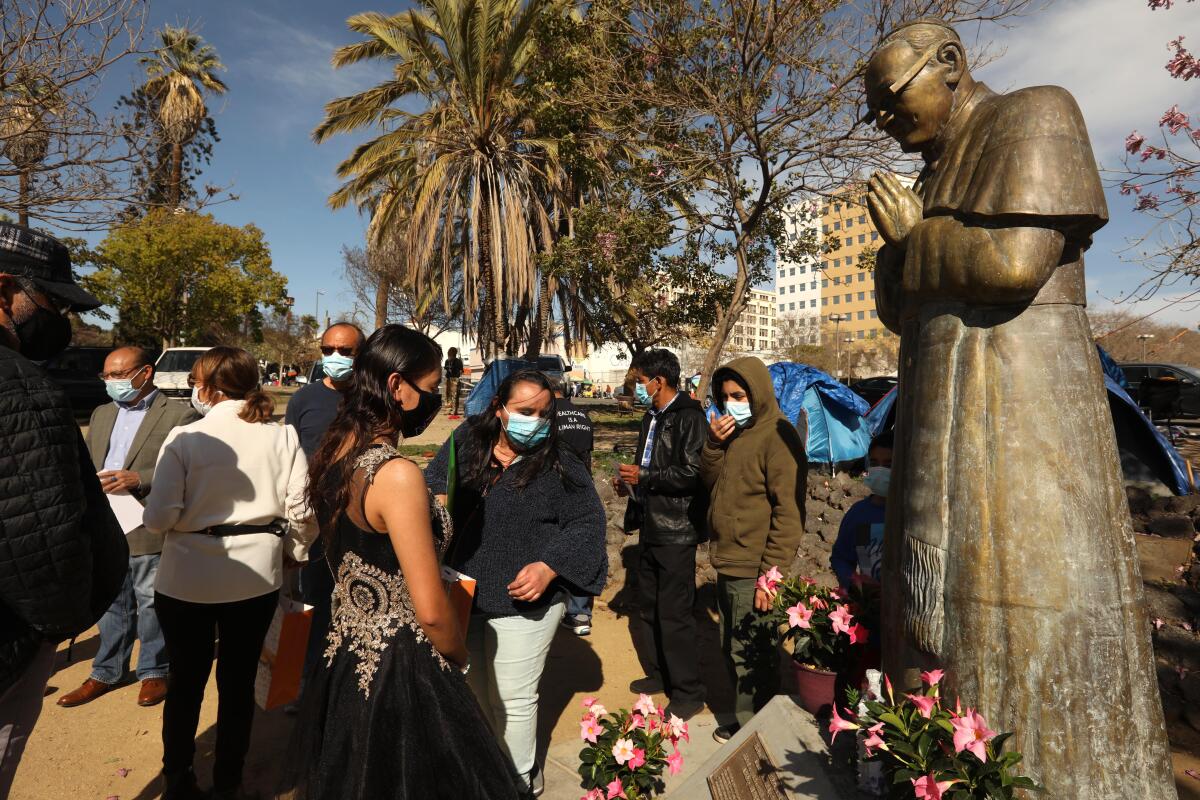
[866,20,1176,800]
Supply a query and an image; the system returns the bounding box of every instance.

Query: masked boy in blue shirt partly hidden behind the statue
[829,431,892,589]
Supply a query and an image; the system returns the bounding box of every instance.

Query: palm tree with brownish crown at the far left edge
[0,78,61,225]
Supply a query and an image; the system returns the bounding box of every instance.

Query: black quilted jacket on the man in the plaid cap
[0,347,130,693]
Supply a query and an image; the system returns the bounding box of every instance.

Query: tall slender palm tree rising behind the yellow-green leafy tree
[142,25,228,207]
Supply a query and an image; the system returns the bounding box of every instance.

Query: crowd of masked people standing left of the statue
[0,220,830,800]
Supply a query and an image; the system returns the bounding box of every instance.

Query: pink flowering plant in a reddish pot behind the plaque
[758,567,870,714]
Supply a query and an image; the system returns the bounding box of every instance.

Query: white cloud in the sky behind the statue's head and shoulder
[977,0,1200,168]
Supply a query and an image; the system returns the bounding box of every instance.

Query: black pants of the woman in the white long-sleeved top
[155,591,280,790]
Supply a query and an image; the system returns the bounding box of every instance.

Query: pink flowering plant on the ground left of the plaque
[580,694,690,800]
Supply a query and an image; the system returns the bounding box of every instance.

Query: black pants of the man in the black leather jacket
[637,545,704,703]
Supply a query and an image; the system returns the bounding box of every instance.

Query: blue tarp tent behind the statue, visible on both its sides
[866,381,1193,494]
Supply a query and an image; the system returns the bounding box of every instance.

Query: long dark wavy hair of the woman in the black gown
[307,325,442,530]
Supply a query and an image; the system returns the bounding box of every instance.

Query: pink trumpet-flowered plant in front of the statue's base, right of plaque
[829,669,1043,800]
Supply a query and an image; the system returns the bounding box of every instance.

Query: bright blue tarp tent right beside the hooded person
[768,361,871,464]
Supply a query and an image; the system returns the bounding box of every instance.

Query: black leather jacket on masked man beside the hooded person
[625,392,708,545]
